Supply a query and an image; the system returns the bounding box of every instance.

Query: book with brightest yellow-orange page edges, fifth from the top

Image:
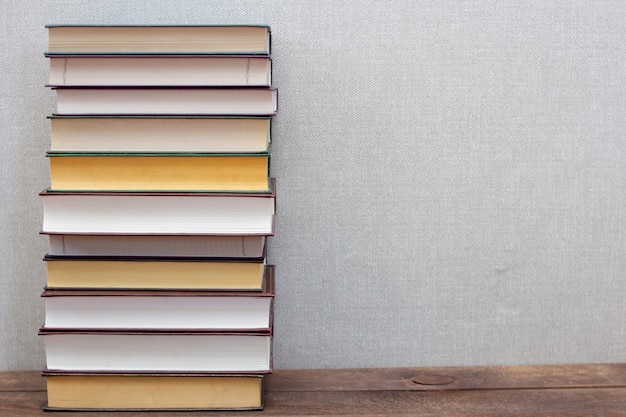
[47,152,270,191]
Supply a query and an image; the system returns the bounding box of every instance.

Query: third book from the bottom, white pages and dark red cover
[41,266,274,332]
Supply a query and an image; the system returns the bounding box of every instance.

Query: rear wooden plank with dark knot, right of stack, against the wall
[267,363,626,391]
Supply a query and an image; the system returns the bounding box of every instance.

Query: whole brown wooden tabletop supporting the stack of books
[0,363,626,417]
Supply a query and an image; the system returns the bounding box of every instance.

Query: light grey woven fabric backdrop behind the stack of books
[0,0,626,369]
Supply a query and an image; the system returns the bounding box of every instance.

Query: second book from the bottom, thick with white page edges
[39,327,272,374]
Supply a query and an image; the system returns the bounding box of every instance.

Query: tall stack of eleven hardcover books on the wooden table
[40,25,277,410]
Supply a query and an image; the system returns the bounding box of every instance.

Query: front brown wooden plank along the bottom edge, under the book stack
[0,388,626,417]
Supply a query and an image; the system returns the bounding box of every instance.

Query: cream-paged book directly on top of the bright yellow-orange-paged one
[49,115,271,153]
